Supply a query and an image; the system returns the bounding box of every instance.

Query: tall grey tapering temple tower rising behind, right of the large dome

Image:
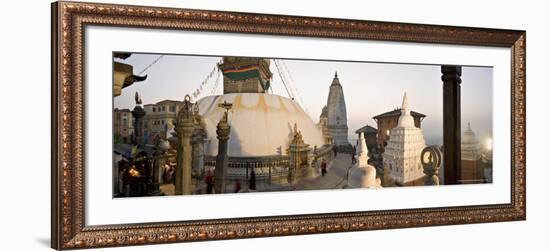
[327,73,349,146]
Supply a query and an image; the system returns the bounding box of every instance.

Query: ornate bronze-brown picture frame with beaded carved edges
[51,2,526,250]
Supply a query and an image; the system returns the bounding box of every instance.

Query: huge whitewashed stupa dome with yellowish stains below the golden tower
[197,93,323,157]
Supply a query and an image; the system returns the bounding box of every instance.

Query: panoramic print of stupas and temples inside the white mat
[112,52,493,198]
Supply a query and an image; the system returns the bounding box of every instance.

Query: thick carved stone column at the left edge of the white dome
[175,95,194,195]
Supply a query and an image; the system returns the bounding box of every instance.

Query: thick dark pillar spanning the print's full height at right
[441,65,462,185]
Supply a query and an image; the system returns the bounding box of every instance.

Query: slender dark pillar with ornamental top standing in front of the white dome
[214,111,231,193]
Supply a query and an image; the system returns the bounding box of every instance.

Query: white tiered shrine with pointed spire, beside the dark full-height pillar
[383,93,426,185]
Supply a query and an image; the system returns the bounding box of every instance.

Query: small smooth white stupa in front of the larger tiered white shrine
[348,133,382,188]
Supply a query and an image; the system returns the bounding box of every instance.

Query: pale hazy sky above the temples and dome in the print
[114,54,493,144]
